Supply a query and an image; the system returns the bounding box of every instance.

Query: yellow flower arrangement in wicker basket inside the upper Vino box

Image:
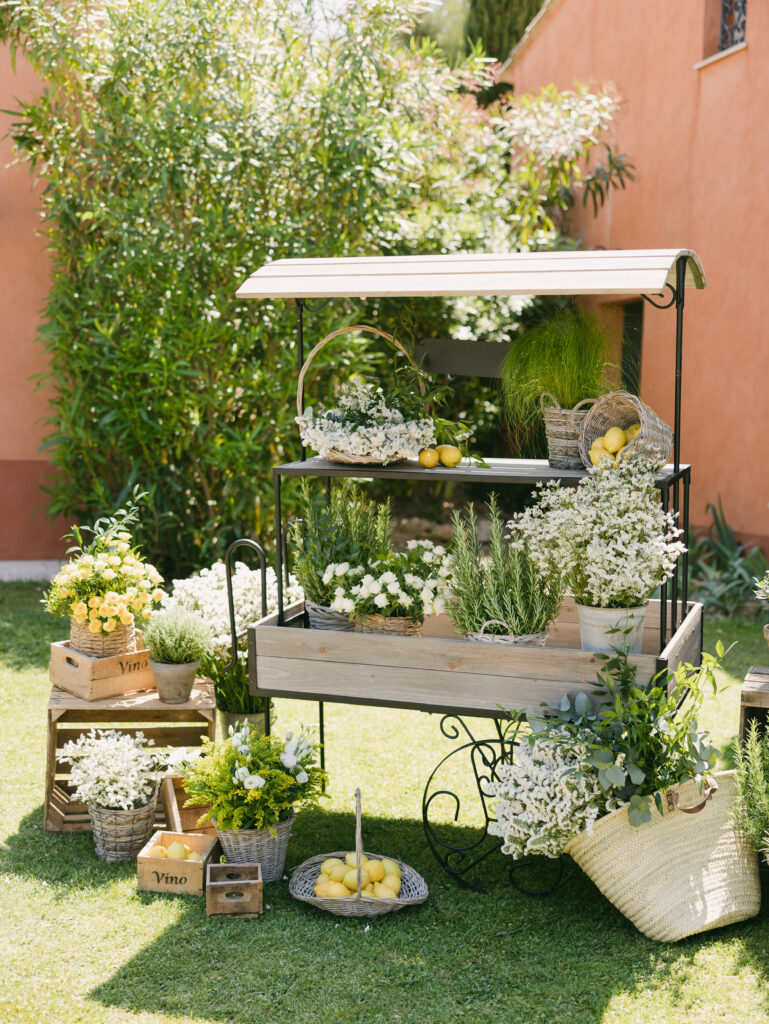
[43,494,165,657]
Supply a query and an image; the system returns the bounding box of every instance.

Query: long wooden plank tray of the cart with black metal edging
[249,600,702,717]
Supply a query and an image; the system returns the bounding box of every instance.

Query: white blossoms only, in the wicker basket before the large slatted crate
[60,729,160,811]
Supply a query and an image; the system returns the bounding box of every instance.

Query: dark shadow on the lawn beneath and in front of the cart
[83,811,769,1024]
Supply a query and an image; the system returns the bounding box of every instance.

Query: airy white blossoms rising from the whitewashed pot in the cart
[508,456,686,608]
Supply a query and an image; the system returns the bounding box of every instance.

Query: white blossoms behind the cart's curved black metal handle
[165,562,304,659]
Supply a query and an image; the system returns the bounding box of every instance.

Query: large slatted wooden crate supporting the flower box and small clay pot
[44,679,216,831]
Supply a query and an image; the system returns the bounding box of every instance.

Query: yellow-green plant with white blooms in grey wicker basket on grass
[182,722,327,882]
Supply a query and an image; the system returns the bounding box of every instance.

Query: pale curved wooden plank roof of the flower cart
[237,249,706,299]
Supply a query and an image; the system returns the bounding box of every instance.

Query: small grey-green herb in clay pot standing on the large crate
[144,608,211,703]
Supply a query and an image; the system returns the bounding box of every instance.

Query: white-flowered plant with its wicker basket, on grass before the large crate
[60,729,162,861]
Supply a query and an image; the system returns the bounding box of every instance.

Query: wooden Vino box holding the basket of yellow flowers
[48,640,156,700]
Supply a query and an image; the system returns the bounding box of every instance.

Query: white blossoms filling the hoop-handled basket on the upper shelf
[296,379,436,463]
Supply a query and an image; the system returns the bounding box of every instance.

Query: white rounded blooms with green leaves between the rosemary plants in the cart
[324,541,452,623]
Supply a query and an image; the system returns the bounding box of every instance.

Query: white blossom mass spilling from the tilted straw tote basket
[488,729,607,858]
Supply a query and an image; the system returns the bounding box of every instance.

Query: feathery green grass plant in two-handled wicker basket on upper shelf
[502,306,608,469]
